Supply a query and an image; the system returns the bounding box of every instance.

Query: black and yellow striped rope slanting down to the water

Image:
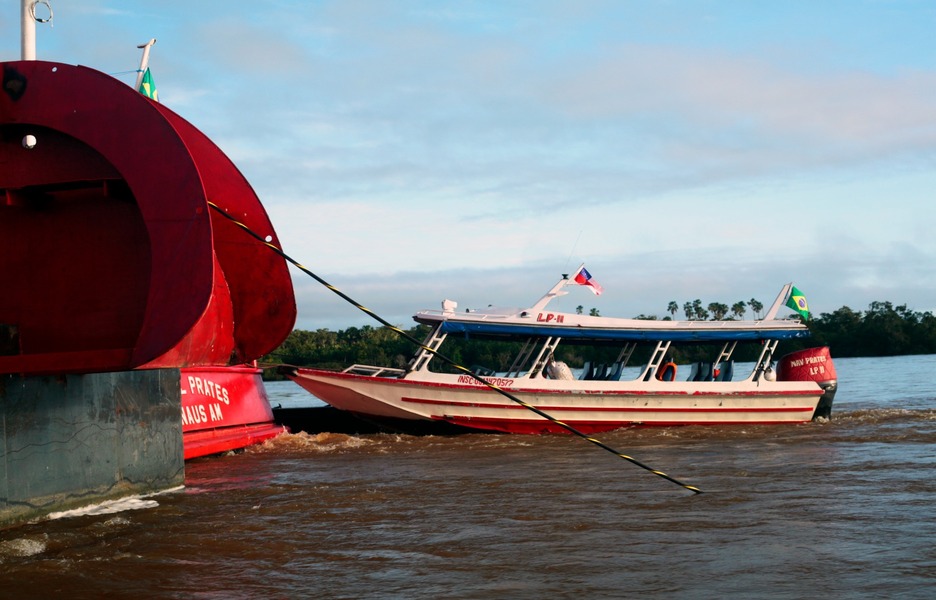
[208,201,702,494]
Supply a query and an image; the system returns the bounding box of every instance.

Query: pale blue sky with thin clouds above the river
[0,0,936,330]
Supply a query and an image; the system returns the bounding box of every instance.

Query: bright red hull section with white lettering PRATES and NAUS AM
[180,366,285,460]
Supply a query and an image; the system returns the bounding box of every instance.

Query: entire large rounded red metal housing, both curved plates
[0,61,296,374]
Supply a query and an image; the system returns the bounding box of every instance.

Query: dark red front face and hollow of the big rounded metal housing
[0,61,213,372]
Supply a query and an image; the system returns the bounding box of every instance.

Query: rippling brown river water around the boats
[0,356,936,600]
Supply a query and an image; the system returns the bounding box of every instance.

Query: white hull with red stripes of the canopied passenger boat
[285,356,831,434]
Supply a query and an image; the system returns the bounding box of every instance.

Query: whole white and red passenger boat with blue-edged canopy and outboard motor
[281,267,837,434]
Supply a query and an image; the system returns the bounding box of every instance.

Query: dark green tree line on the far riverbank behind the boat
[263,299,936,378]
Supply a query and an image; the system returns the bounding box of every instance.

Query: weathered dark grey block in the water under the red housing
[0,369,185,527]
